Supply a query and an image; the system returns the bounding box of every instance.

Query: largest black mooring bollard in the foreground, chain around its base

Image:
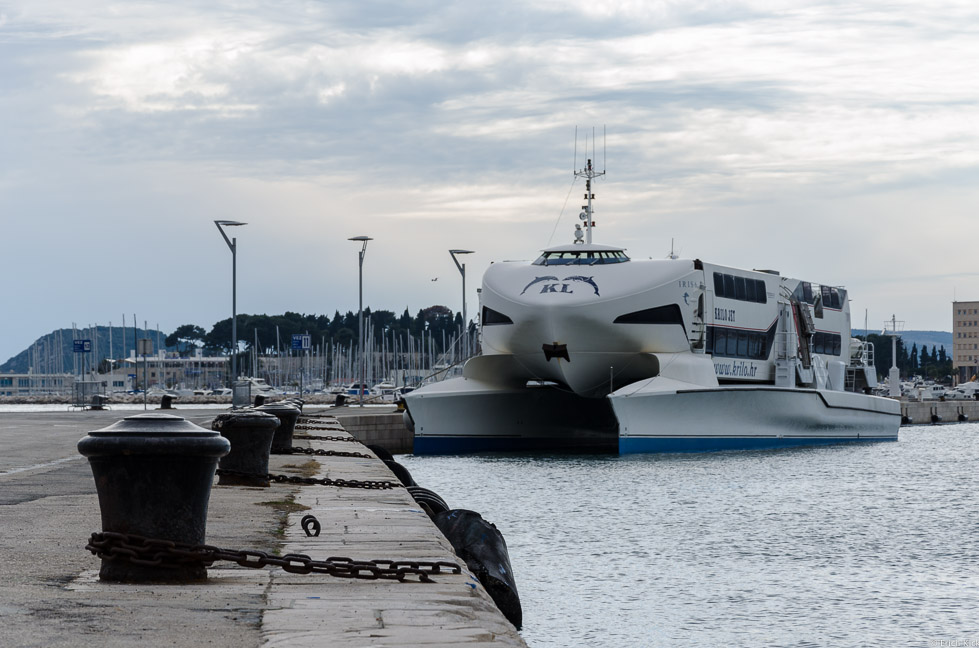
[78,413,230,583]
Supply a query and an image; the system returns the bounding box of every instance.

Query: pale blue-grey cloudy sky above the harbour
[0,0,979,360]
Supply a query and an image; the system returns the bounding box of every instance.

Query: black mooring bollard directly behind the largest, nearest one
[211,409,279,487]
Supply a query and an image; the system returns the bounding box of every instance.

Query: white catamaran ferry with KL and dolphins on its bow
[405,160,901,454]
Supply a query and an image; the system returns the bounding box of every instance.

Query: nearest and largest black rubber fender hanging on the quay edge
[434,509,523,630]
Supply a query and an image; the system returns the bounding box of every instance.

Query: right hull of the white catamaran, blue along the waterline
[609,379,901,454]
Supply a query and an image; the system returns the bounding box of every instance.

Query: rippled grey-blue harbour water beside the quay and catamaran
[398,423,979,648]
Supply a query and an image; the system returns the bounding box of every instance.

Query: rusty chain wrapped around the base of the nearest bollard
[85,532,462,583]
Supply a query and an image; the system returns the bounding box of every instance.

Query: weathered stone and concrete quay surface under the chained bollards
[0,409,525,648]
